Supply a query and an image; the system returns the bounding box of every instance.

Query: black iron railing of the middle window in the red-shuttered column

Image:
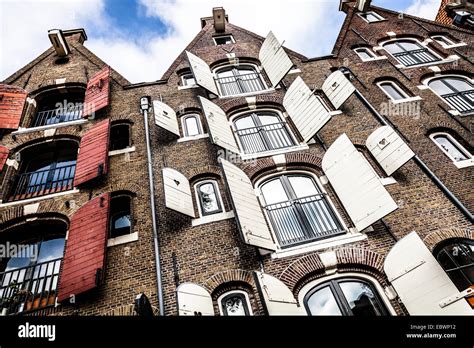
[10,163,76,201]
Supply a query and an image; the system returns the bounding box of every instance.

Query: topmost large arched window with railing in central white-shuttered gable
[216,65,266,96]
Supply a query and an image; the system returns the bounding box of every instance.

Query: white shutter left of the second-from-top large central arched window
[199,96,240,154]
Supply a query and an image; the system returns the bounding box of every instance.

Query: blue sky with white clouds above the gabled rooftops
[0,0,440,82]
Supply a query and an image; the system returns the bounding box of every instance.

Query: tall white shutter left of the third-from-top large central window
[220,158,276,251]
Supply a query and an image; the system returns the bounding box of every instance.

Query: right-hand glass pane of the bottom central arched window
[339,281,384,317]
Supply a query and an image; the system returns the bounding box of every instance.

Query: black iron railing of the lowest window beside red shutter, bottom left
[0,258,62,314]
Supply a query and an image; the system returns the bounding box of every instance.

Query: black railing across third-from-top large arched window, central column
[265,194,344,247]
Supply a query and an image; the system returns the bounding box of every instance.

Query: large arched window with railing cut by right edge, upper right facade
[428,76,474,114]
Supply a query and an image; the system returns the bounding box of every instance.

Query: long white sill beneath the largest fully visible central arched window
[271,232,367,259]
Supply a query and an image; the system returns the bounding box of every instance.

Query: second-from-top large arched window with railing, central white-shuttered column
[233,111,295,154]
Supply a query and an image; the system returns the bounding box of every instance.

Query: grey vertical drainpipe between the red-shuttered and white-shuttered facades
[140,97,165,316]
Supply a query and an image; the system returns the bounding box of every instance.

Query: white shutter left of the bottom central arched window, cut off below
[255,271,307,315]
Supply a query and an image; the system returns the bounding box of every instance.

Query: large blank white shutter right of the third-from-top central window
[322,133,398,231]
